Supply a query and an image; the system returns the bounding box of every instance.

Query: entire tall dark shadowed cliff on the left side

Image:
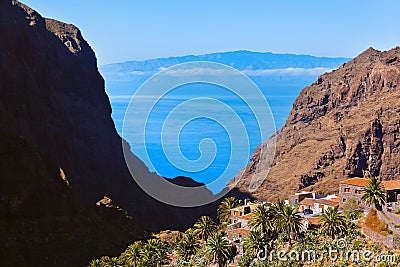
[0,0,234,266]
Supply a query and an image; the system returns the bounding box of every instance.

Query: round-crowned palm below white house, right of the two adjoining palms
[319,207,346,240]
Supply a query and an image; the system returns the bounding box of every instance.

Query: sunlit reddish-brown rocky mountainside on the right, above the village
[233,47,400,200]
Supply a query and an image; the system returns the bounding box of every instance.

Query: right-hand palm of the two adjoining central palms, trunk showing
[273,205,302,246]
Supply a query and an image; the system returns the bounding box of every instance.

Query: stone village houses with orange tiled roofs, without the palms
[226,178,400,253]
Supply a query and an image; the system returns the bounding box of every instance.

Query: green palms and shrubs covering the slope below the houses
[90,195,400,267]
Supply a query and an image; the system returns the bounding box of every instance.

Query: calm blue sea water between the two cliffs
[106,74,317,192]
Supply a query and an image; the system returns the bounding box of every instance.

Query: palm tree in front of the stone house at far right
[361,177,386,210]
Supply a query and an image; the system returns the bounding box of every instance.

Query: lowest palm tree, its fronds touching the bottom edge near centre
[205,232,236,267]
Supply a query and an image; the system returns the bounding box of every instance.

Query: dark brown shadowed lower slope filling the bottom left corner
[0,133,143,266]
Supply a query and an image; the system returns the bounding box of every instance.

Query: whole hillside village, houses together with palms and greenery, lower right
[90,177,400,267]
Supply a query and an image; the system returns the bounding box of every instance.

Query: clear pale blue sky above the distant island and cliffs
[21,0,400,64]
